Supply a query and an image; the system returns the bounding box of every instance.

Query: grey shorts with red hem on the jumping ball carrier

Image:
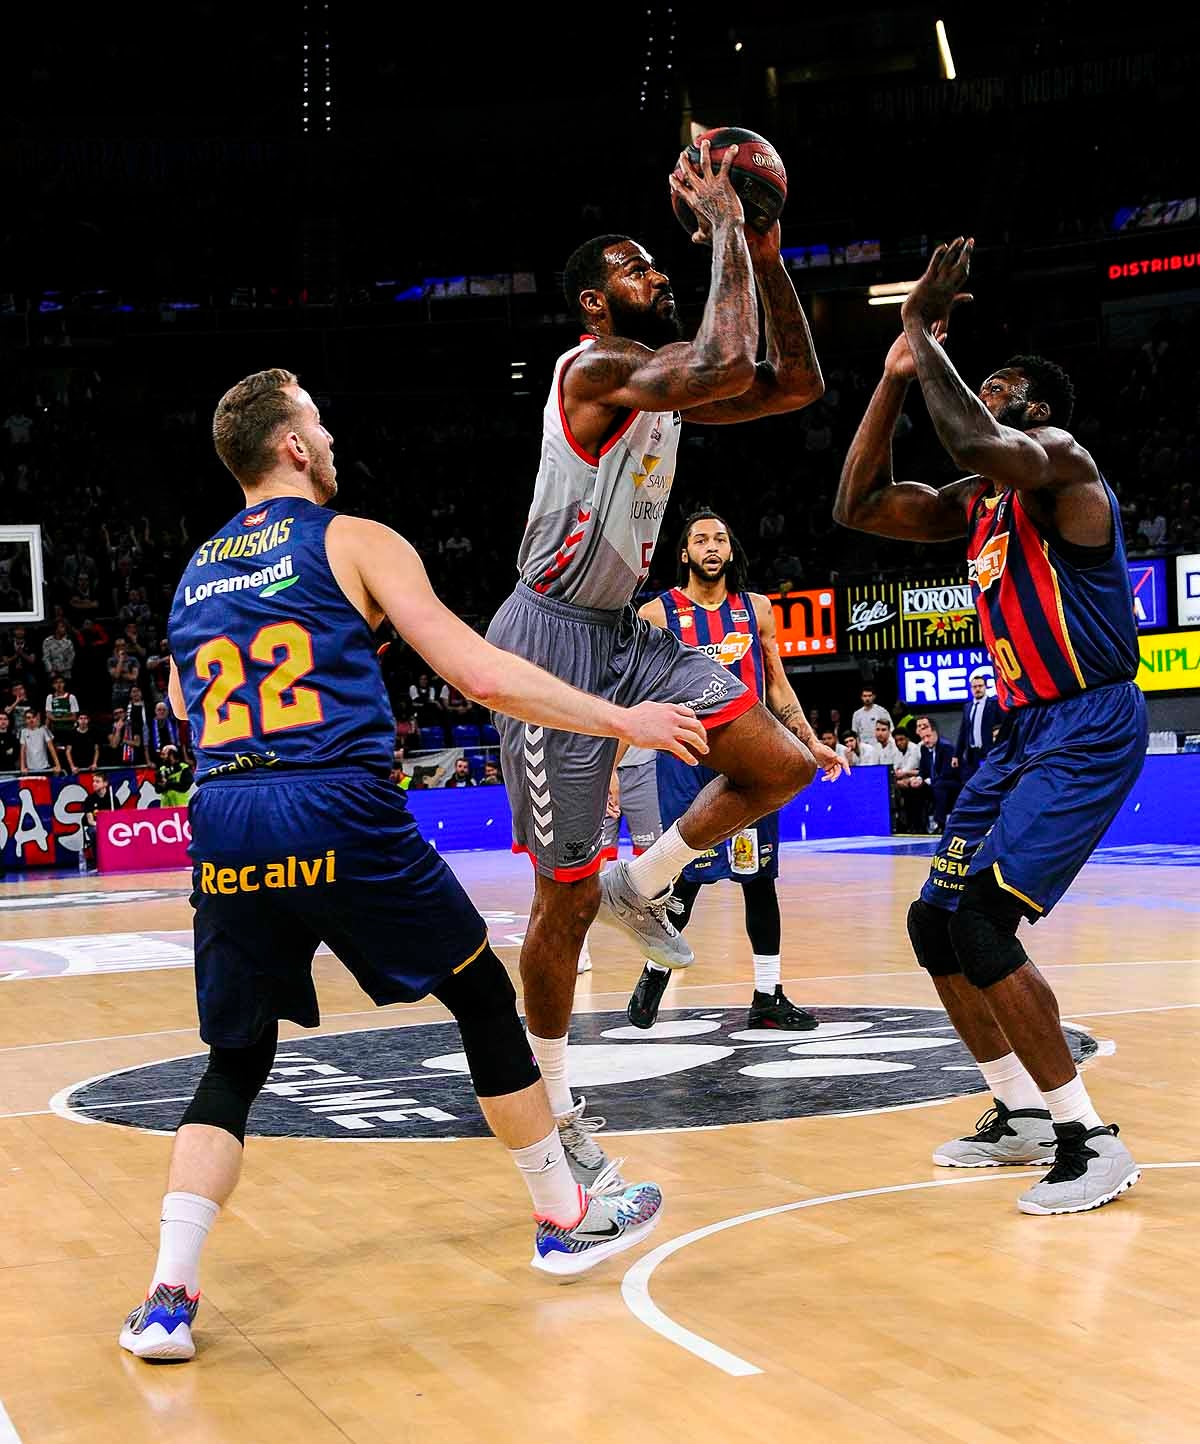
[488,583,755,882]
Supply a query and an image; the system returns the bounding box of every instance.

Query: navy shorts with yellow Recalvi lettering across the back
[191,767,487,1048]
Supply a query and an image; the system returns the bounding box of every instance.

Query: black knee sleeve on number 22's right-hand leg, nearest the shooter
[433,947,542,1097]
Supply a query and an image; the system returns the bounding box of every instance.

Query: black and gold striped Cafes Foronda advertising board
[842,575,982,651]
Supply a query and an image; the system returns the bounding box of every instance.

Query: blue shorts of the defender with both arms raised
[921,682,1147,921]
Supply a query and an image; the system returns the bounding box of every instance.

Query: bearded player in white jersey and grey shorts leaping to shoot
[488,142,829,1190]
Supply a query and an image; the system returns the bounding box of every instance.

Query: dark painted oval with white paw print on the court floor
[55,995,1097,1139]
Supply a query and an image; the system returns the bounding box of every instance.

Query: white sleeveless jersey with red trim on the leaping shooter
[517,336,679,611]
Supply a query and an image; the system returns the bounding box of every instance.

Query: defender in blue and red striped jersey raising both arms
[833,238,1147,1214]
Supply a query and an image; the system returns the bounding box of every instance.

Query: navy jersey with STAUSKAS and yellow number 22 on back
[168,497,396,781]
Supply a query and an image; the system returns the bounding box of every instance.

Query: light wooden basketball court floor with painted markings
[0,842,1200,1444]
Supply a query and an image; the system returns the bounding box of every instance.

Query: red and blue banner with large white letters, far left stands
[0,767,159,869]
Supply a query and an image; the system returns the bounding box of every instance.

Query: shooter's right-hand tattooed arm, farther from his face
[687,221,825,426]
